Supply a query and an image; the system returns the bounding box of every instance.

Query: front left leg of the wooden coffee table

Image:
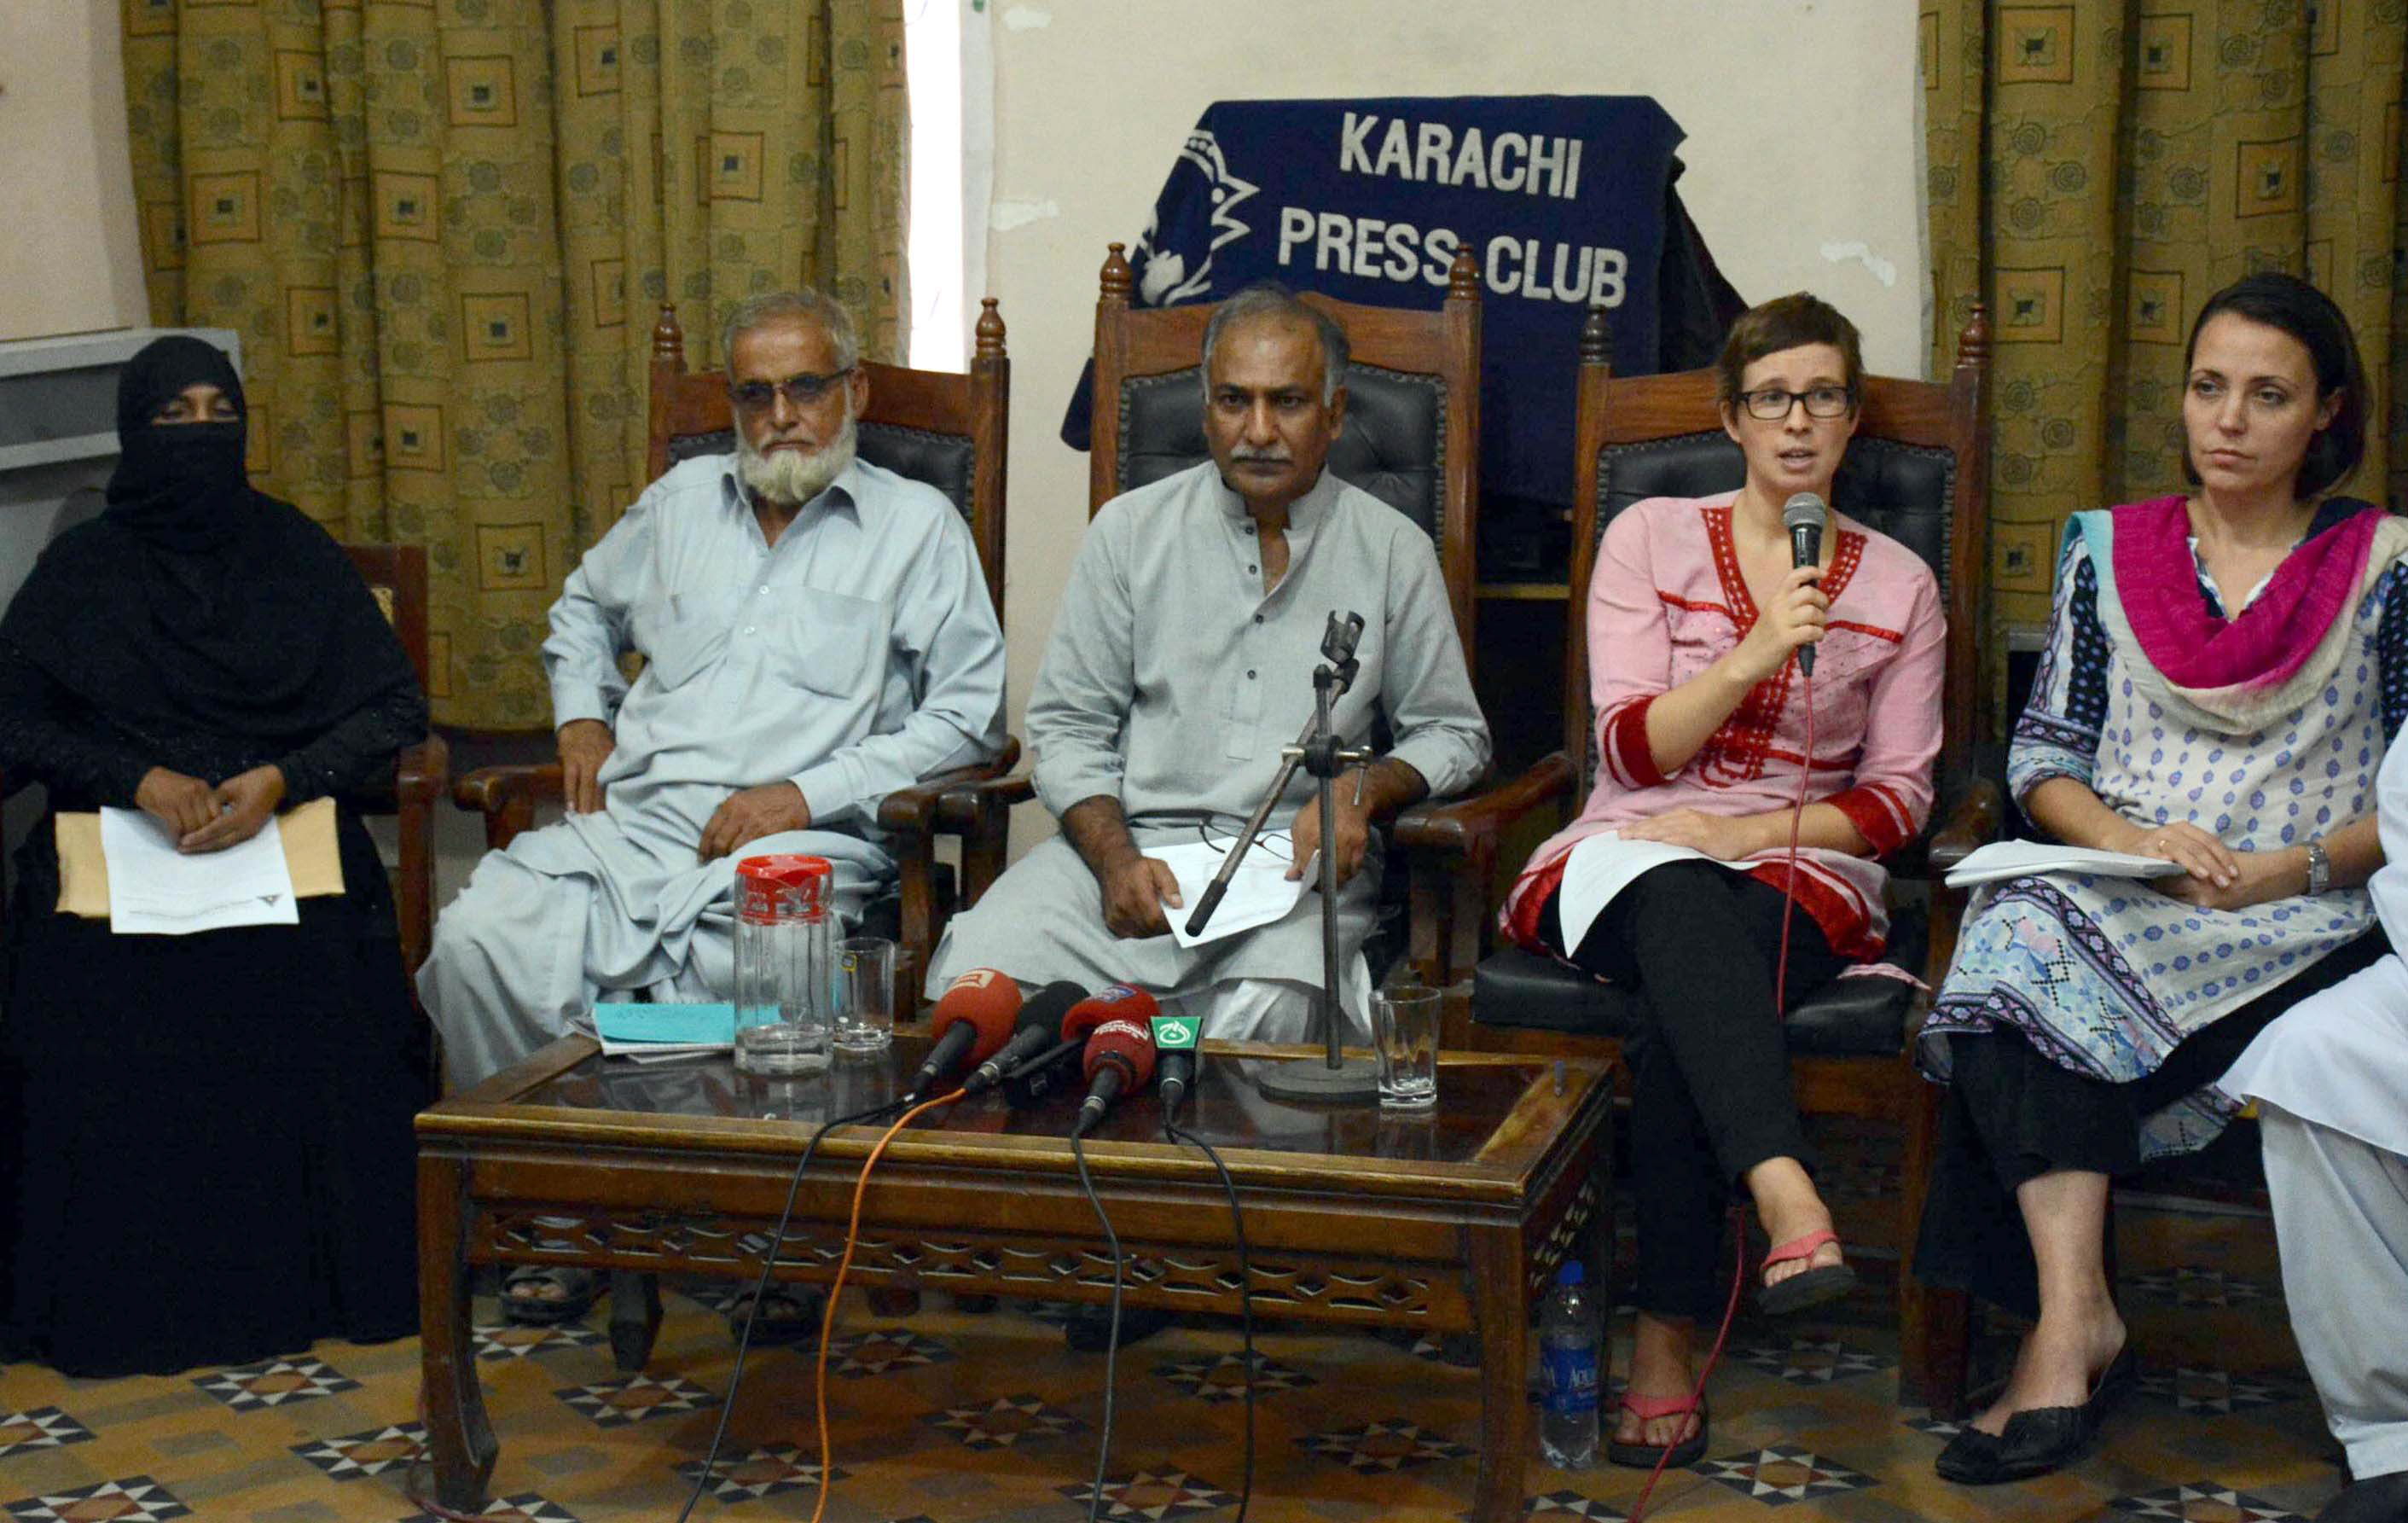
[419,1157,501,1514]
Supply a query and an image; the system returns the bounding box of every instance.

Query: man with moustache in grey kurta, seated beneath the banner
[932,289,1488,1038]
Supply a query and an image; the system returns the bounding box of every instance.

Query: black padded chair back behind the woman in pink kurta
[1597,432,1955,602]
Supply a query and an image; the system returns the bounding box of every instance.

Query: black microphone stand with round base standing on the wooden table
[1187,610,1380,1102]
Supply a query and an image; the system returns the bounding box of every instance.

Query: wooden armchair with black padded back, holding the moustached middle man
[954,243,1481,959]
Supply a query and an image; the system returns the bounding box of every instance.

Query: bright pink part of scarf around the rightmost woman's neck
[2112,497,2384,689]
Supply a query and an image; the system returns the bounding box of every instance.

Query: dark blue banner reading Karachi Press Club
[1065,96,1683,503]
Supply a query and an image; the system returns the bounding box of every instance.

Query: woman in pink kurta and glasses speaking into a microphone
[1503,294,1946,1465]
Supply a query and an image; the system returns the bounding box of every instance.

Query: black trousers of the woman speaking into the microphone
[1539,863,1847,1323]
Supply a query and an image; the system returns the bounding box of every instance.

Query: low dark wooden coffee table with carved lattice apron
[416,1034,1611,1523]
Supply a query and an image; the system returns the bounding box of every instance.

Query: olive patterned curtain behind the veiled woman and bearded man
[125,0,910,728]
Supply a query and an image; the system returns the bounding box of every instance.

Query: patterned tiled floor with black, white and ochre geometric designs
[0,1132,2338,1523]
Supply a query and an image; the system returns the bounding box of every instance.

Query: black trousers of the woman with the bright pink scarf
[1914,930,2391,1316]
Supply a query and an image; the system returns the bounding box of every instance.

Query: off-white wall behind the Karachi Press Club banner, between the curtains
[972,0,1929,848]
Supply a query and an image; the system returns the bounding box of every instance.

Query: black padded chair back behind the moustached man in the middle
[1120,363,1448,544]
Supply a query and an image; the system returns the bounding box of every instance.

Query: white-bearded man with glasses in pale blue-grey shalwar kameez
[419,296,1004,1084]
